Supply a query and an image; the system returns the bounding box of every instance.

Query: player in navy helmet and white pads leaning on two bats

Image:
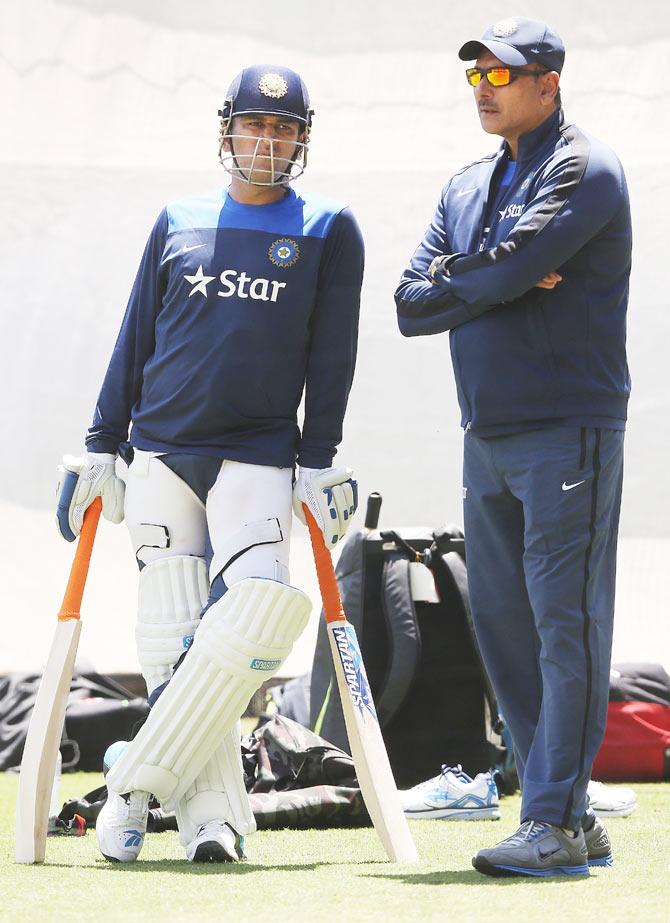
[57,65,364,863]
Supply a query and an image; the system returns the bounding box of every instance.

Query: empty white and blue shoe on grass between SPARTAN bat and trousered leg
[398,766,500,820]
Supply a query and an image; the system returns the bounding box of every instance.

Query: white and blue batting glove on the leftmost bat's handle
[56,452,126,542]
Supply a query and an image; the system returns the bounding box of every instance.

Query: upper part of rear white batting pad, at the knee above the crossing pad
[135,555,209,695]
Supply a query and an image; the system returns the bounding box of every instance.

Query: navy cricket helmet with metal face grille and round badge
[219,64,314,186]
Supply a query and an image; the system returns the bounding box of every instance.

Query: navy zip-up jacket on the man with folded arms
[396,112,631,435]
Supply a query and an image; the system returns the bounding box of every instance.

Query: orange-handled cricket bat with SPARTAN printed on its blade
[303,504,419,862]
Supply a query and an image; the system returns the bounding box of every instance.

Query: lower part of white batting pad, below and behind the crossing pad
[175,721,256,846]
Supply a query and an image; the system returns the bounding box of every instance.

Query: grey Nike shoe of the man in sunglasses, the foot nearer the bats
[472,820,589,878]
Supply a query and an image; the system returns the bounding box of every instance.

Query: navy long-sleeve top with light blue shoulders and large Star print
[86,189,363,468]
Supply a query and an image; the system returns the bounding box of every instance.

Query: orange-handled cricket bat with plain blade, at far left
[14,497,102,864]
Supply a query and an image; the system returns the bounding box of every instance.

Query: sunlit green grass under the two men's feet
[0,773,670,923]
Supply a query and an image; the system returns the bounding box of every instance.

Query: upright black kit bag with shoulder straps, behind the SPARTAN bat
[308,494,504,788]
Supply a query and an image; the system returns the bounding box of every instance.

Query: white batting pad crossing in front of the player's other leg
[106,578,311,811]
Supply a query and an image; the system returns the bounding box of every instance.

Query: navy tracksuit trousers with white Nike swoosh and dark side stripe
[463,426,624,830]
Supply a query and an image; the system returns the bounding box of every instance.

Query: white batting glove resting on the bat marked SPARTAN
[293,468,358,548]
